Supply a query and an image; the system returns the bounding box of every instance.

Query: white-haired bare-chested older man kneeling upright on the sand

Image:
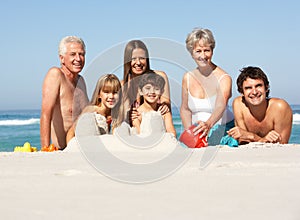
[40,36,88,150]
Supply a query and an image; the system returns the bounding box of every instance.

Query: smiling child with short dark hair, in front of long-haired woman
[132,72,176,137]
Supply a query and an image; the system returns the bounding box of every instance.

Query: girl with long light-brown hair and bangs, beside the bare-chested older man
[67,74,122,143]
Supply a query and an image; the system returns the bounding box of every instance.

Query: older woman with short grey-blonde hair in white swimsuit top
[180,28,235,145]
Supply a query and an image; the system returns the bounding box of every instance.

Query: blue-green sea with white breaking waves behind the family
[0,105,300,152]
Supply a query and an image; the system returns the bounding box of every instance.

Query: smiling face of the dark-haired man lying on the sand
[243,77,267,106]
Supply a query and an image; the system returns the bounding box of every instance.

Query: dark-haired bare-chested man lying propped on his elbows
[228,67,293,144]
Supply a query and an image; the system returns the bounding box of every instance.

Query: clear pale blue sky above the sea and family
[0,0,300,110]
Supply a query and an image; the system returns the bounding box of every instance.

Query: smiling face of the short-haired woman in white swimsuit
[192,39,213,66]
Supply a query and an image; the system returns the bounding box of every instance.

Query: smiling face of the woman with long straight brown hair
[131,48,147,75]
